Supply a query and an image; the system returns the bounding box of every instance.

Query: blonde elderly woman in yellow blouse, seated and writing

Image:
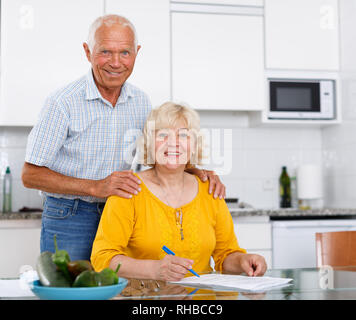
[91,102,267,281]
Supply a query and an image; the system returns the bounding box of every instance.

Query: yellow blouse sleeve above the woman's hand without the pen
[212,199,246,271]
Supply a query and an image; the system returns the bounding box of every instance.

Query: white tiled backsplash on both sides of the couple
[0,111,322,210]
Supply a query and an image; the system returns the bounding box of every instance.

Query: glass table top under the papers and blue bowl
[0,266,356,300]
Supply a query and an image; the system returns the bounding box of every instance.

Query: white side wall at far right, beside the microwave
[322,0,356,208]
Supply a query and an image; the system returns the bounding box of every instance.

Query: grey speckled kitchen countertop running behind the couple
[0,206,356,220]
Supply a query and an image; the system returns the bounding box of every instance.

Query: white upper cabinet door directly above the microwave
[265,0,339,71]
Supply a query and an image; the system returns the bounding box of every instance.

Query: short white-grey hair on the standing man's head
[87,14,137,52]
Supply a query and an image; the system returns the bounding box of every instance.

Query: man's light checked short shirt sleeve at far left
[25,97,69,168]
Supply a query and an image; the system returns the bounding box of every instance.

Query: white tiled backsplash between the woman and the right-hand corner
[199,111,322,208]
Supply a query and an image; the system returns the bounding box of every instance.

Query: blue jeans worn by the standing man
[41,197,105,261]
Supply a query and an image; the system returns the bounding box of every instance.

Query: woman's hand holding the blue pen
[153,254,193,281]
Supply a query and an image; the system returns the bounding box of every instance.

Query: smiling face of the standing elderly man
[84,24,140,91]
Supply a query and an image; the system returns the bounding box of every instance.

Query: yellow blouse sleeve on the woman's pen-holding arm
[90,196,135,271]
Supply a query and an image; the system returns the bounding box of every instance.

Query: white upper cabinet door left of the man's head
[0,0,103,126]
